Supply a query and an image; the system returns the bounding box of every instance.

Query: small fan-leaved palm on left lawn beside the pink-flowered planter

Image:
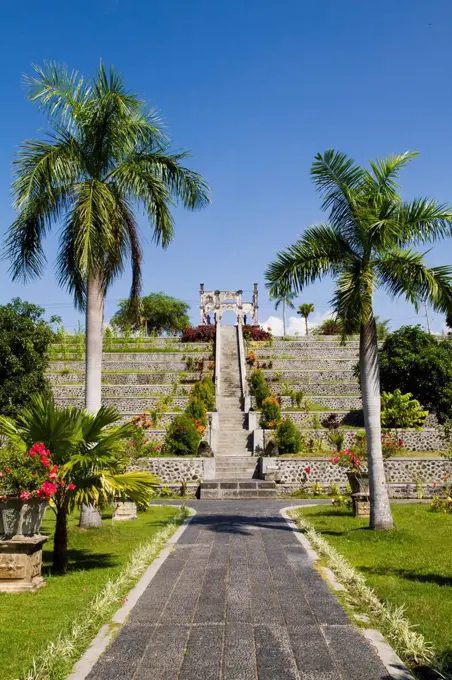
[0,395,159,572]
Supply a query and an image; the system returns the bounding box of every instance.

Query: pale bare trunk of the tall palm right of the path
[359,317,394,531]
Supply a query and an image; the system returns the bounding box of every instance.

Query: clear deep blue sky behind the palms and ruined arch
[0,0,452,330]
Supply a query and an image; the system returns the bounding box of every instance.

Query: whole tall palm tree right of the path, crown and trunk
[266,150,452,529]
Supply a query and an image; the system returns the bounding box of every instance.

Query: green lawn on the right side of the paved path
[302,503,452,670]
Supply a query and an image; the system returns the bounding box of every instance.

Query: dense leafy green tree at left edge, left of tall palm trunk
[0,298,54,417]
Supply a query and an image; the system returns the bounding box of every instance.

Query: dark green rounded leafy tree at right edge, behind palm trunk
[379,326,452,422]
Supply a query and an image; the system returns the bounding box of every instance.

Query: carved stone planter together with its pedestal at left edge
[0,498,48,593]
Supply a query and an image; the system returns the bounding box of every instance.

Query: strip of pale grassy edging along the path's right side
[289,510,441,677]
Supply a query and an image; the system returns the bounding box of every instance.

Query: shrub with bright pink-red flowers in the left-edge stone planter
[0,443,75,502]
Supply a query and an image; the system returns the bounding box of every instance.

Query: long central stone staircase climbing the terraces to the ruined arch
[201,326,276,498]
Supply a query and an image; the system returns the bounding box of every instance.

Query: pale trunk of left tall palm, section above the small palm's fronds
[85,274,104,413]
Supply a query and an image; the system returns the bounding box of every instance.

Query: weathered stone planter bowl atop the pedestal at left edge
[0,498,48,540]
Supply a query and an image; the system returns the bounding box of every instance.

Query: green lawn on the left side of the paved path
[0,507,177,680]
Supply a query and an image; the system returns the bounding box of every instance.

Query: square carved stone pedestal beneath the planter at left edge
[0,534,47,593]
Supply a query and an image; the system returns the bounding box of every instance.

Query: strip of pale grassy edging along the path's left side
[22,506,189,680]
